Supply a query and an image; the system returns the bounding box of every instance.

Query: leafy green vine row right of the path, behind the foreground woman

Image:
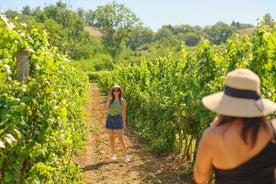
[99,26,276,161]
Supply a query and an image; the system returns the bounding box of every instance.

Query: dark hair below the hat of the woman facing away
[218,115,266,147]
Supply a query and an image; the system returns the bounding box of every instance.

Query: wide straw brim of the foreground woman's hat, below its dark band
[202,92,276,117]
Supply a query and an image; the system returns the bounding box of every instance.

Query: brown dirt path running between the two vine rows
[76,83,188,184]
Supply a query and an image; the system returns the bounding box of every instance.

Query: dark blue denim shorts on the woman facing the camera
[105,114,123,130]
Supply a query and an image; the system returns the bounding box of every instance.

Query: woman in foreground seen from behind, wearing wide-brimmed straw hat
[193,69,276,184]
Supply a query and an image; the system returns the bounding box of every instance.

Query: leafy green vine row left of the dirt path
[0,14,88,183]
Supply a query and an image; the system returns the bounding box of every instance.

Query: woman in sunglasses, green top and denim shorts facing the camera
[105,85,130,163]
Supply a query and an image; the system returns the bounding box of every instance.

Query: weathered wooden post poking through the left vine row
[16,51,29,82]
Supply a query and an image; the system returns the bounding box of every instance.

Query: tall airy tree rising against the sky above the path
[86,1,142,57]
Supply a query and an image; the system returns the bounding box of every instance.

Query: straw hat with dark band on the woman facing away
[202,69,276,118]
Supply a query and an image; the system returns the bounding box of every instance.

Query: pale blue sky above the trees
[0,0,276,31]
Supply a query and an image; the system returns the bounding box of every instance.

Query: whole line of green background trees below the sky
[5,1,274,71]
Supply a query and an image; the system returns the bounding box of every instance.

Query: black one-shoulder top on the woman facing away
[214,142,276,184]
